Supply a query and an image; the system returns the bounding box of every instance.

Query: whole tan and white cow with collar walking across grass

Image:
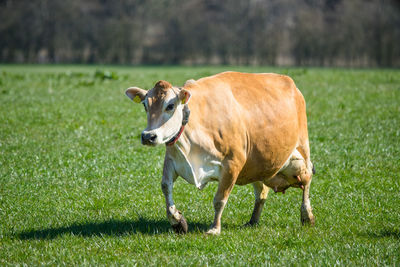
[125,72,314,235]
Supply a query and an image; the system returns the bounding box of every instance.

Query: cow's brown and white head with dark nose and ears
[125,81,190,146]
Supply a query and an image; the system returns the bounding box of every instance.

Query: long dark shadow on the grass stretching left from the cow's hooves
[16,218,207,240]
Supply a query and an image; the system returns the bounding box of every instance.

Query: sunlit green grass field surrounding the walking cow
[0,65,400,266]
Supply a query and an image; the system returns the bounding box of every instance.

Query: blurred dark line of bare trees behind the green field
[0,0,400,67]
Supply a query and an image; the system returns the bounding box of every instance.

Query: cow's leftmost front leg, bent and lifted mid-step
[161,158,188,233]
